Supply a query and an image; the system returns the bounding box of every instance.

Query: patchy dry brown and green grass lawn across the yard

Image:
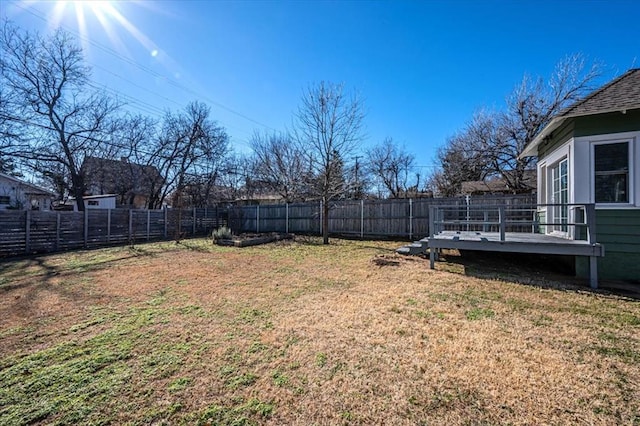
[0,238,640,425]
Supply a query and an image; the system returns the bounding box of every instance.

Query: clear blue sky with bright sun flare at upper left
[0,0,640,176]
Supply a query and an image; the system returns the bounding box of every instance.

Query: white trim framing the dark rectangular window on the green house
[580,132,639,210]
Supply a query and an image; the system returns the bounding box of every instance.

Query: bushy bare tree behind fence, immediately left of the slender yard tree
[251,133,310,203]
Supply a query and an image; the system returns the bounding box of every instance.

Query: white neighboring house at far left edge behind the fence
[0,173,55,210]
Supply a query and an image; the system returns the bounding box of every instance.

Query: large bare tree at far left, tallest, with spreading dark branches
[0,23,118,210]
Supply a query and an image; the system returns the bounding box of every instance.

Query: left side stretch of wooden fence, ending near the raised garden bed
[0,207,226,256]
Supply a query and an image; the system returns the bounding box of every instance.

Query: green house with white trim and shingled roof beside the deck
[521,68,640,281]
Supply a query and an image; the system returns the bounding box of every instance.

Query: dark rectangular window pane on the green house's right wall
[593,142,629,203]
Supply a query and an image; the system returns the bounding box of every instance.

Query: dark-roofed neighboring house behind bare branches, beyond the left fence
[81,157,164,209]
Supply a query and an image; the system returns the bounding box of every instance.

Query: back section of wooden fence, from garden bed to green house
[229,194,536,239]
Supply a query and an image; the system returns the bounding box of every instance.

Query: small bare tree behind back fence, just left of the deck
[366,138,419,198]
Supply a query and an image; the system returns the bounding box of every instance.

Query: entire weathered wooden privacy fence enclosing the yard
[0,195,536,257]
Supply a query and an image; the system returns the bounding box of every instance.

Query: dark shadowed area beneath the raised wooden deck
[440,250,640,301]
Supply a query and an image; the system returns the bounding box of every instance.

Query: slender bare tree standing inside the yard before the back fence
[294,82,364,244]
